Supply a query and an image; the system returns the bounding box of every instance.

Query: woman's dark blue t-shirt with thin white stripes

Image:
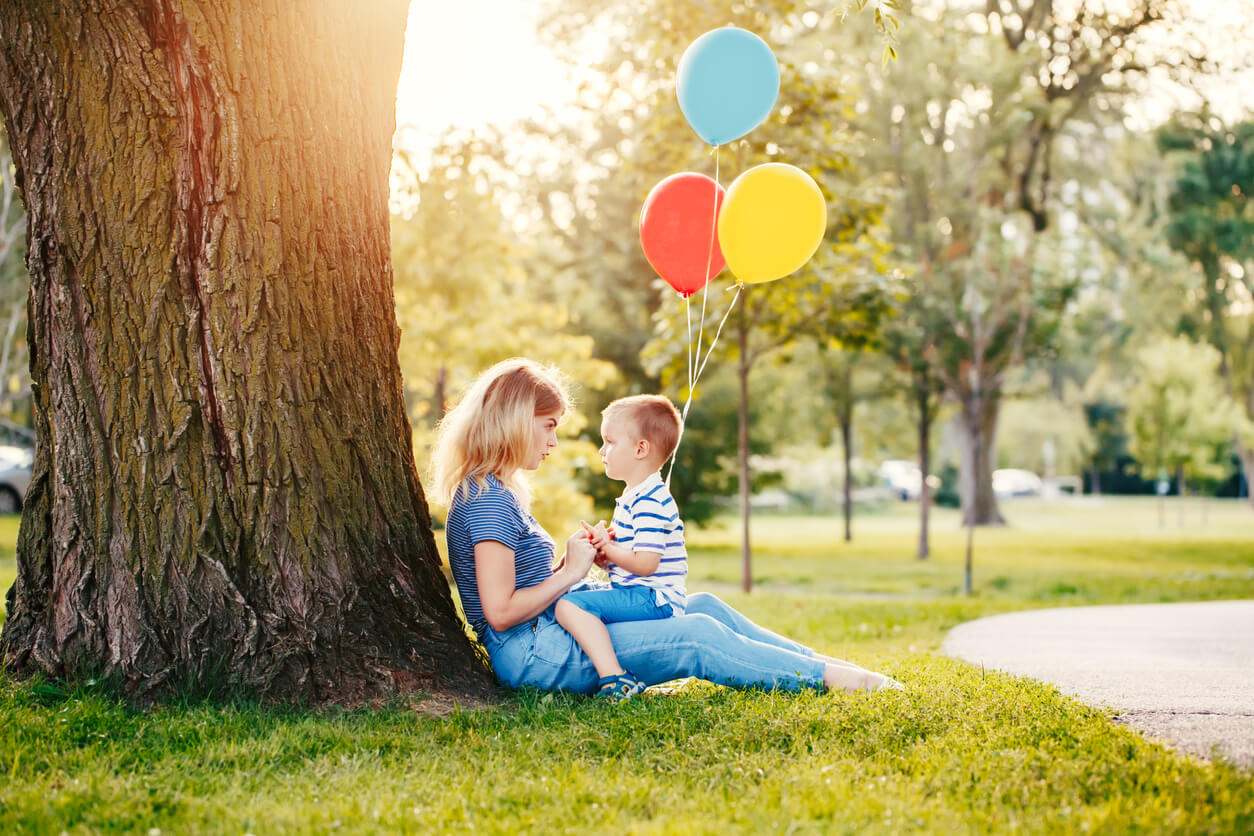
[445,474,554,639]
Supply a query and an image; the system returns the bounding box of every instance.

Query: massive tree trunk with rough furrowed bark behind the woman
[0,0,490,703]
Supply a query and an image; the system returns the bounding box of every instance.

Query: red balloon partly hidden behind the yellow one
[640,172,727,297]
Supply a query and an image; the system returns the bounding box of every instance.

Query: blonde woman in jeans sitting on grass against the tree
[435,360,900,693]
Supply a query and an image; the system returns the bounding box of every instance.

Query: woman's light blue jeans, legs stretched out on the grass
[483,593,825,693]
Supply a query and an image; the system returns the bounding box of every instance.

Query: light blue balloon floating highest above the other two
[675,26,780,145]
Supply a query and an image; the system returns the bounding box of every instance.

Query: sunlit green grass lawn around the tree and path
[0,499,1254,835]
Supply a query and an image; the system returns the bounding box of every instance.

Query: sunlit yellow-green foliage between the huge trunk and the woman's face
[383,137,616,535]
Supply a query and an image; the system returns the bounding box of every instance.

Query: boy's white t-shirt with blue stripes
[609,473,688,612]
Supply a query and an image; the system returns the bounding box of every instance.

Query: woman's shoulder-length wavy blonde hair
[433,357,571,508]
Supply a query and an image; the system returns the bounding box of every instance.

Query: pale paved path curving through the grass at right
[941,600,1254,767]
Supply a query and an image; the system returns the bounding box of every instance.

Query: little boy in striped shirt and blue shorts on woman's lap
[556,395,688,702]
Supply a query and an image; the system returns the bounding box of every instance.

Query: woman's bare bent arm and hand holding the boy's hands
[474,533,597,632]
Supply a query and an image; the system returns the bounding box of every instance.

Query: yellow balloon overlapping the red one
[719,163,828,285]
